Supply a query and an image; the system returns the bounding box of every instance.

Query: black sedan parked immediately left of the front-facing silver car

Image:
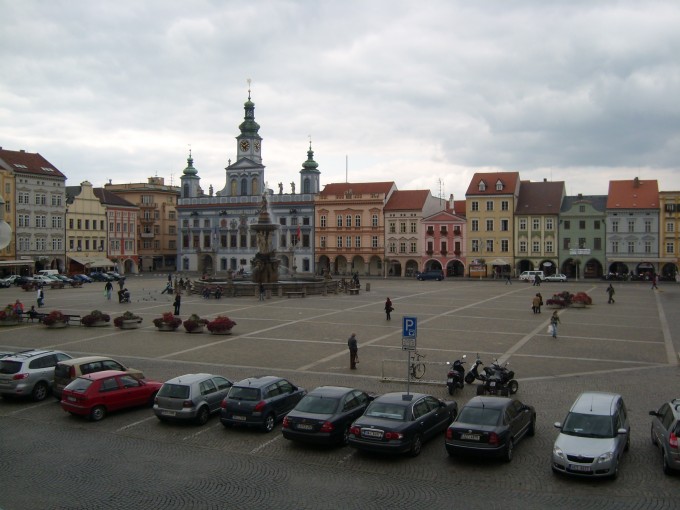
[445,397,536,462]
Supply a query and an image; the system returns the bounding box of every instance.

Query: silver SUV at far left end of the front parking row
[0,349,71,402]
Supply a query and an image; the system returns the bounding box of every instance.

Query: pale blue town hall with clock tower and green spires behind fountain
[177,91,320,277]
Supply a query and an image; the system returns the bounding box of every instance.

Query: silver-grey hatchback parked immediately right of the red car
[153,374,233,425]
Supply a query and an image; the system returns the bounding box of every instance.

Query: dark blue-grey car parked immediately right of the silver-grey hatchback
[220,375,307,432]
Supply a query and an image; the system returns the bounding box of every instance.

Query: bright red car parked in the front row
[61,370,163,421]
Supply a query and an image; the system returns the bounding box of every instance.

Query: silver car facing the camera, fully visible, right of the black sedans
[552,391,630,478]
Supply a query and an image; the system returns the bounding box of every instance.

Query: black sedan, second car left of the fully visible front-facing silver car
[349,393,458,457]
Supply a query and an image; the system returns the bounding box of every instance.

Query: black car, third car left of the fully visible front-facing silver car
[281,386,373,445]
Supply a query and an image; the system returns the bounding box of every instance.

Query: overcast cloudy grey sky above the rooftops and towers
[0,0,680,199]
